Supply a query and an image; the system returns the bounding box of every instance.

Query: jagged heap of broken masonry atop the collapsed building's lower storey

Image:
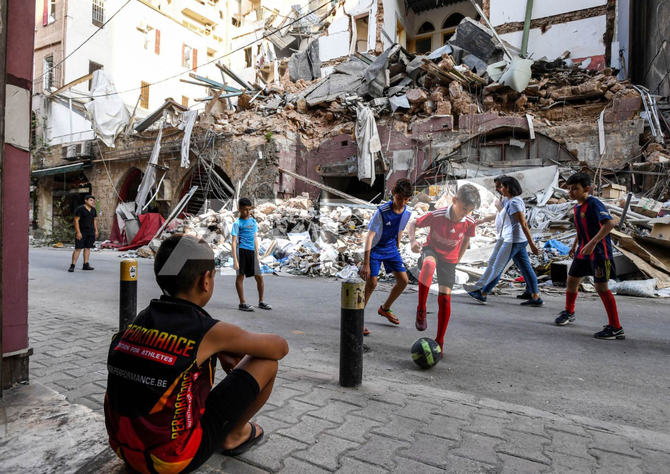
[192,18,640,147]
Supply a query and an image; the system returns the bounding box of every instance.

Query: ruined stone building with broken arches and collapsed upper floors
[33,0,667,260]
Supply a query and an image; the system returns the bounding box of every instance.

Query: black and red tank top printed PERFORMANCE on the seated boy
[105,296,218,474]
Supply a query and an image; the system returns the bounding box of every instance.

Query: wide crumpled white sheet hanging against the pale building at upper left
[85,69,130,148]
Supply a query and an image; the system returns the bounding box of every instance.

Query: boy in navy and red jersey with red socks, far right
[555,173,626,340]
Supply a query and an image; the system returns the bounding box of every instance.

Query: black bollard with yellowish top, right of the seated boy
[340,278,365,387]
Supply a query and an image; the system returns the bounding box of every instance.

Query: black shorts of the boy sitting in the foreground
[182,369,260,472]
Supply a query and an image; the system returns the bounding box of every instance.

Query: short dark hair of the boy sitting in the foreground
[154,234,215,296]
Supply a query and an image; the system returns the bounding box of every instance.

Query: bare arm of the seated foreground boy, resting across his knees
[197,321,288,364]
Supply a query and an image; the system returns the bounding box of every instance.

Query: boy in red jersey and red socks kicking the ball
[408,184,481,354]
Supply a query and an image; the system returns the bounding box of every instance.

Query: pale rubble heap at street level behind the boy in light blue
[137,195,429,276]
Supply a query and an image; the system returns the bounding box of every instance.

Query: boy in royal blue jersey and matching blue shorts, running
[360,178,414,336]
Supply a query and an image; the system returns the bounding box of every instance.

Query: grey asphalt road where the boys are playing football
[30,248,670,433]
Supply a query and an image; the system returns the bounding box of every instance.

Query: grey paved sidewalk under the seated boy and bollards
[0,311,670,474]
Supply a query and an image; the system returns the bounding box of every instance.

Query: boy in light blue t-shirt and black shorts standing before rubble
[230,198,272,311]
